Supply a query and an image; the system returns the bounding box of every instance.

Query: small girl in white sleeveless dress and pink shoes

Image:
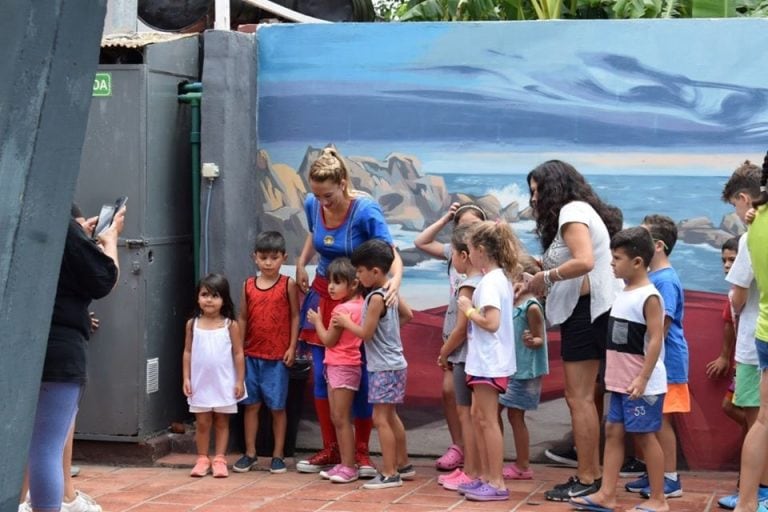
[184,274,245,478]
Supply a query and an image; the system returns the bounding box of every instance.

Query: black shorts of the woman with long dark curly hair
[560,294,609,362]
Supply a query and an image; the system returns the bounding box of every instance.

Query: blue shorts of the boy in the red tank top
[240,356,288,411]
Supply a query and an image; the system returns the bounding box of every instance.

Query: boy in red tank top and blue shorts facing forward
[232,231,299,473]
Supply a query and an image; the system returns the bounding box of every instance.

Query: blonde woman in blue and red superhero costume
[296,147,403,478]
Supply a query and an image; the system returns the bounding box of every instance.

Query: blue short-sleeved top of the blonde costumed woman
[304,194,392,276]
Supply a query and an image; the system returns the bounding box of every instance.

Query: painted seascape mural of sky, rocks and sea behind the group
[257,19,768,308]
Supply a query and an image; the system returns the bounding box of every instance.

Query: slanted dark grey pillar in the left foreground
[0,0,105,512]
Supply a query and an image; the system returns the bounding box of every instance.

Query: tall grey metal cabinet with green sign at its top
[75,36,199,442]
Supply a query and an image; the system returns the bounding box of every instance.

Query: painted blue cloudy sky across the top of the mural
[259,19,768,150]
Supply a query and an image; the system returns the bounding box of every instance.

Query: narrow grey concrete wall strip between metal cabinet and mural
[200,30,259,302]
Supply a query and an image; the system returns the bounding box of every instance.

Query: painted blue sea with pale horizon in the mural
[261,141,736,300]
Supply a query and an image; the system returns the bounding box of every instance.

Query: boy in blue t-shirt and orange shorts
[625,215,691,498]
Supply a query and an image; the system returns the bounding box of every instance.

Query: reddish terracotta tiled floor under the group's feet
[66,455,736,512]
